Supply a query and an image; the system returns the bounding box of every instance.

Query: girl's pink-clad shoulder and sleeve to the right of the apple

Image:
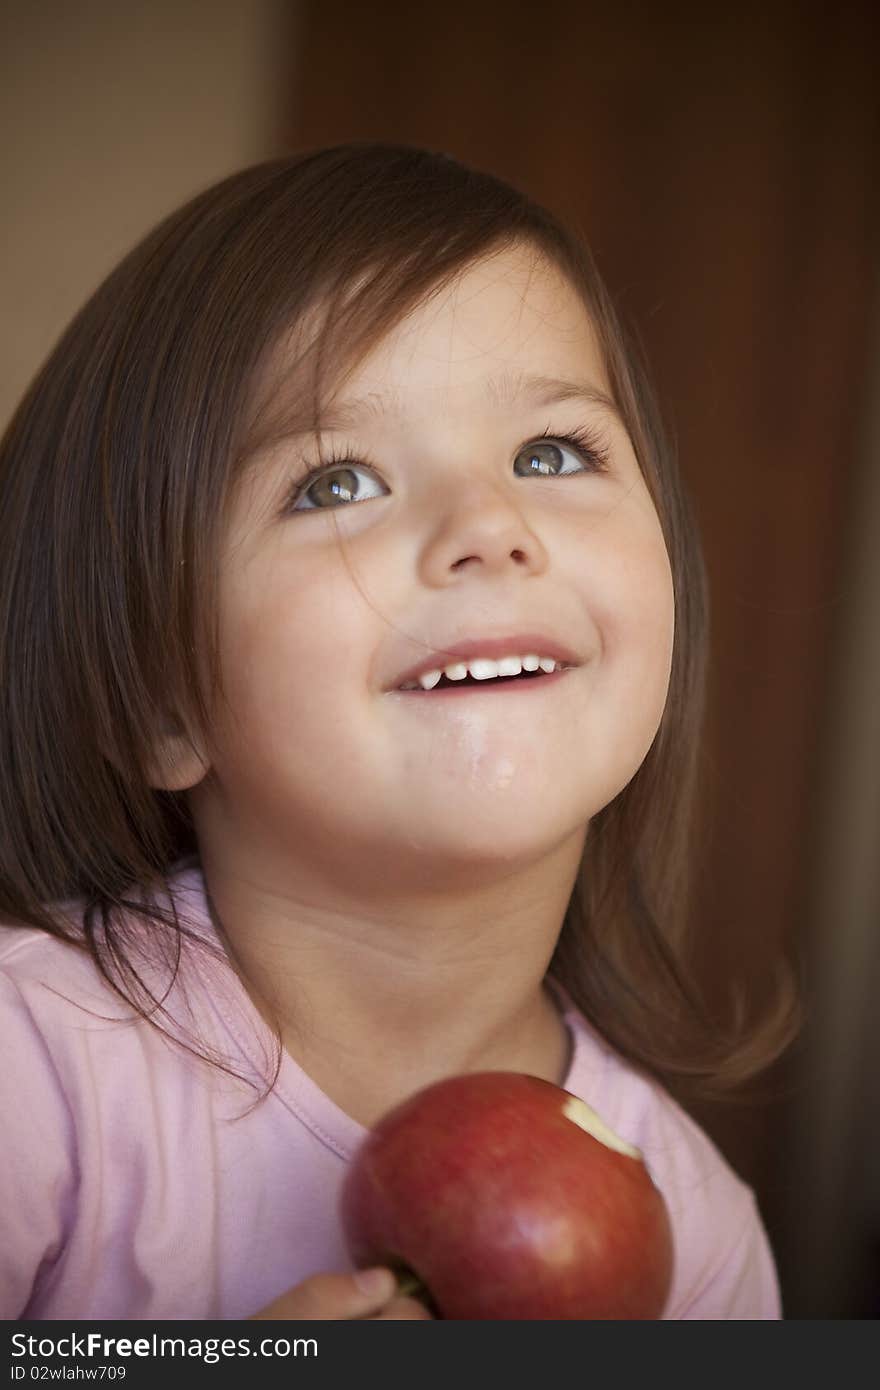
[566,1011,781,1319]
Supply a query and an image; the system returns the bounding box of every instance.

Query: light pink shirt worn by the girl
[0,863,781,1321]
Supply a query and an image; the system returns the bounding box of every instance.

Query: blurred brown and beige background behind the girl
[0,0,880,1319]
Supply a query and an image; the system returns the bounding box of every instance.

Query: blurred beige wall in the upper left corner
[0,0,298,427]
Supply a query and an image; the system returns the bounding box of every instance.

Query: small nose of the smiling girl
[421,484,548,588]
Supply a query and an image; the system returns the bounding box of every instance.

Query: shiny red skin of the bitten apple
[339,1072,673,1321]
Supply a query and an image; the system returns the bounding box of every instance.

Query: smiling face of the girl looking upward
[183,249,673,887]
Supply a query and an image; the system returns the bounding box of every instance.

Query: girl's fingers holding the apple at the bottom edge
[249,1268,431,1322]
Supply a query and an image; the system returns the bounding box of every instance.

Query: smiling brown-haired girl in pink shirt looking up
[0,143,792,1319]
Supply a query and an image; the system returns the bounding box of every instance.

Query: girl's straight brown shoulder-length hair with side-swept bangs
[0,142,797,1097]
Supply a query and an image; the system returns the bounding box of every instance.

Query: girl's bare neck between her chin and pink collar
[202,835,582,1125]
